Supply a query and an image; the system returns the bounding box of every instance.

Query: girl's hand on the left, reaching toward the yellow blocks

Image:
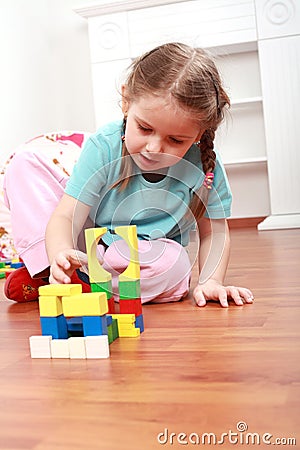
[49,249,88,284]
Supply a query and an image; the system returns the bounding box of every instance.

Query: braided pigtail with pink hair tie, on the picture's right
[189,128,216,221]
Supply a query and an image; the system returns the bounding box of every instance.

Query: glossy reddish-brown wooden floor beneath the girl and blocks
[0,229,300,450]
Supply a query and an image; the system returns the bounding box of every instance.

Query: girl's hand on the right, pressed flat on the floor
[193,279,254,308]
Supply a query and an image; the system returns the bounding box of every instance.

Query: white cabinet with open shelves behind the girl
[76,0,300,229]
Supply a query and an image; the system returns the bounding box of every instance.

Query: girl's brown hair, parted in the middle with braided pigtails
[112,43,230,220]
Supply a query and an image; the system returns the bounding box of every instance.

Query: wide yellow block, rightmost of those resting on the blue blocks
[62,292,108,317]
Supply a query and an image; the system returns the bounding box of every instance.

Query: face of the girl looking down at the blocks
[122,88,203,172]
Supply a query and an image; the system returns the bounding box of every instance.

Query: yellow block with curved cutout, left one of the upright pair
[85,228,112,283]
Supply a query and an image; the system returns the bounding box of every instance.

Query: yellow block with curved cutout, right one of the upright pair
[114,225,140,281]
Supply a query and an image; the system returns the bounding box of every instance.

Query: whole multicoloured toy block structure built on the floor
[30,226,144,358]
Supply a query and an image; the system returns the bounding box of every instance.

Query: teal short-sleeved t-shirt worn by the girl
[65,121,232,246]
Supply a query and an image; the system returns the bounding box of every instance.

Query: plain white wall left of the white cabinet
[0,0,95,166]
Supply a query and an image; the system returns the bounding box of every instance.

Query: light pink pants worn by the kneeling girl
[4,143,191,303]
